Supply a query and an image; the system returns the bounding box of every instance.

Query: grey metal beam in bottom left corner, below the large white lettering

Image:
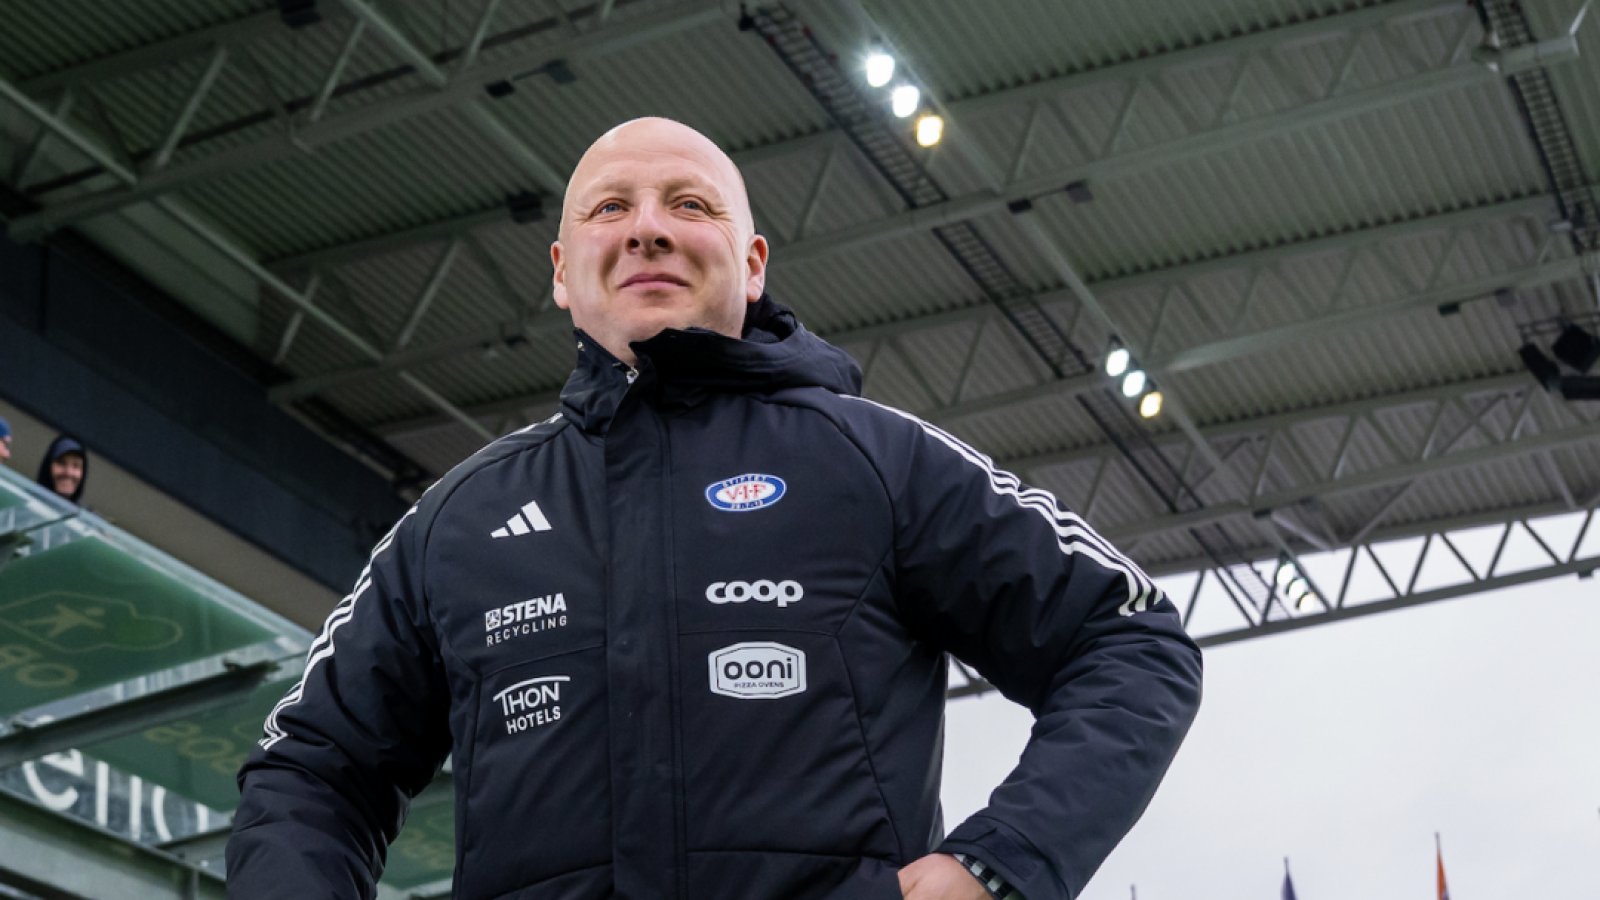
[0,791,226,900]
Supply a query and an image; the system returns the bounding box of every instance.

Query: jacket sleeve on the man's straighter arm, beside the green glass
[227,508,450,900]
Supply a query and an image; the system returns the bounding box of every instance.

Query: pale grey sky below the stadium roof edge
[944,577,1600,900]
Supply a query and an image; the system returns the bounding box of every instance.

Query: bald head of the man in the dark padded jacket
[550,119,766,364]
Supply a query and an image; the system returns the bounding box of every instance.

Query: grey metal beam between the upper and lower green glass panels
[0,658,283,769]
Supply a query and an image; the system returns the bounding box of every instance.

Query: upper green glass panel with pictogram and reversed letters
[0,536,275,716]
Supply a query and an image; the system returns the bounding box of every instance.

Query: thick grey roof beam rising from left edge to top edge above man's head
[10,0,725,240]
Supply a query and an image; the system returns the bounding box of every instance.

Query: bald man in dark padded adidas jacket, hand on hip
[227,119,1200,900]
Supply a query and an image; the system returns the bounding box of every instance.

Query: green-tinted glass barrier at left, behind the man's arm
[0,468,454,889]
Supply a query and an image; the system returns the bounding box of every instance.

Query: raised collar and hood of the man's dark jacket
[562,295,861,432]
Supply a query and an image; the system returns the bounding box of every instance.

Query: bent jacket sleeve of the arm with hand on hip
[851,398,1200,900]
